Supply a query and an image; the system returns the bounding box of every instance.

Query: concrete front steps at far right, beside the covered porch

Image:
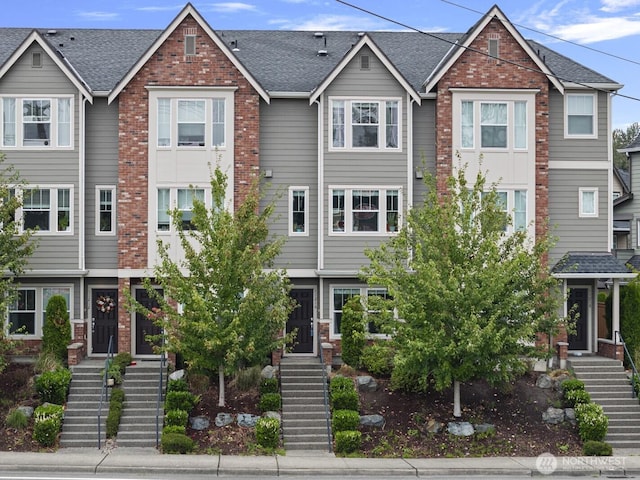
[570,356,640,448]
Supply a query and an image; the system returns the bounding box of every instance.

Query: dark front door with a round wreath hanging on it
[91,288,118,353]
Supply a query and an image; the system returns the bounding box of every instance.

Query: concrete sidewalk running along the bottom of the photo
[0,448,640,477]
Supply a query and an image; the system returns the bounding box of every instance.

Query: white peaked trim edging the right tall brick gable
[424,6,565,94]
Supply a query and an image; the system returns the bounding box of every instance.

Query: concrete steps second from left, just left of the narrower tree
[116,361,167,447]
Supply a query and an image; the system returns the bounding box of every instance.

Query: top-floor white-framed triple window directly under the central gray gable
[329,99,401,151]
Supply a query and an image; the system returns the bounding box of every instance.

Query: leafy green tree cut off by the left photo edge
[0,156,36,372]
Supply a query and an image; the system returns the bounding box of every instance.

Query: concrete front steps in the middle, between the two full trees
[280,357,331,452]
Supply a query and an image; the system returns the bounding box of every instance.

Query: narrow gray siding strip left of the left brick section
[85,98,118,268]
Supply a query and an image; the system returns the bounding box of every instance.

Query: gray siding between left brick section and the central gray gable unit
[260,99,318,269]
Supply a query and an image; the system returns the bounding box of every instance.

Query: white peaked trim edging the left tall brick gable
[109,3,269,103]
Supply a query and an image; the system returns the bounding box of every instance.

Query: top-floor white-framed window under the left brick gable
[156,97,228,148]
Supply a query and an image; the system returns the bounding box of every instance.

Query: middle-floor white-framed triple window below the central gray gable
[329,187,402,235]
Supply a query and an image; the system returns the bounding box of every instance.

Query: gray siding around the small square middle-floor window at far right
[549,169,610,263]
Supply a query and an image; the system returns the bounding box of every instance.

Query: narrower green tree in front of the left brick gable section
[134,167,294,406]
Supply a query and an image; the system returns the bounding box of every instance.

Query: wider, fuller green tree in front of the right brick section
[363,162,561,416]
